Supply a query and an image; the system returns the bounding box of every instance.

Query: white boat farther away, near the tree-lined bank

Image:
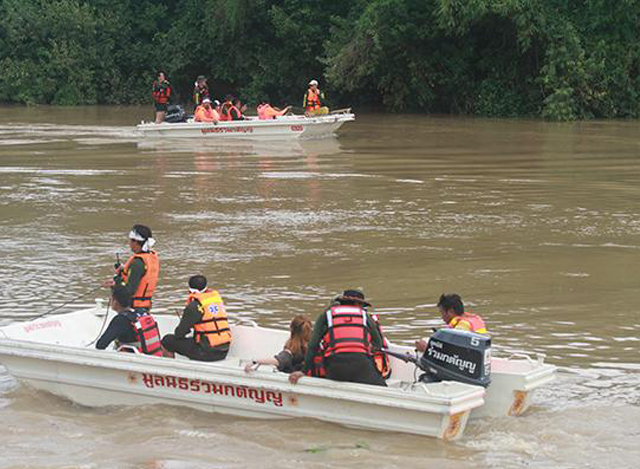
[137,112,355,140]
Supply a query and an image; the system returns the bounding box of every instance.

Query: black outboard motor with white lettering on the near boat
[418,329,491,387]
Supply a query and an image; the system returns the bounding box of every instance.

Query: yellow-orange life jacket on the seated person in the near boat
[187,290,231,347]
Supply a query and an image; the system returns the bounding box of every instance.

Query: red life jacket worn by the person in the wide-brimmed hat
[322,305,371,357]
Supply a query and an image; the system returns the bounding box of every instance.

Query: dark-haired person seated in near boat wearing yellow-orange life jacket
[162,275,231,362]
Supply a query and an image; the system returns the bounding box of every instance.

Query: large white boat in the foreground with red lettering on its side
[0,301,553,440]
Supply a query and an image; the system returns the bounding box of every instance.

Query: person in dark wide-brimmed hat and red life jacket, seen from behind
[289,290,387,386]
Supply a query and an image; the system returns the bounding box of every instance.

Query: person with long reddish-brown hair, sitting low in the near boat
[244,315,313,373]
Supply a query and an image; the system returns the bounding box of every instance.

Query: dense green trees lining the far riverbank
[0,0,640,119]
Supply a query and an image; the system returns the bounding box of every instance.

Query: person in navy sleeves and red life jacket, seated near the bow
[96,285,162,357]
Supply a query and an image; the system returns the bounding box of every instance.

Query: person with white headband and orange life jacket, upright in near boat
[103,225,160,314]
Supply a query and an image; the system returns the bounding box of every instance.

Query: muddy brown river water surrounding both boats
[0,107,640,469]
